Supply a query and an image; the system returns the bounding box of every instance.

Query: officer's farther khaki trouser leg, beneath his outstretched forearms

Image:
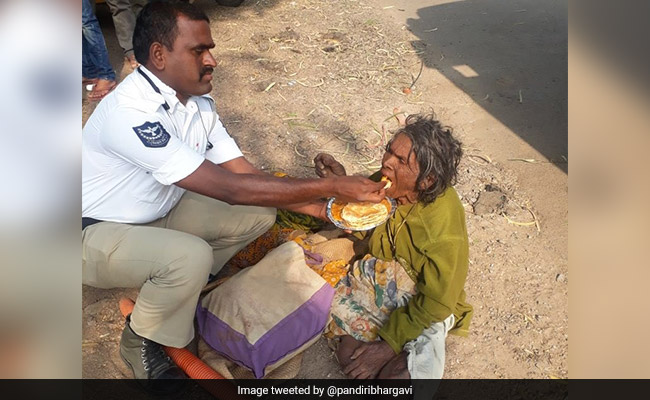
[148,191,276,274]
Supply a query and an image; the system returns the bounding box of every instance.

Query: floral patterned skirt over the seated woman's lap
[324,254,415,342]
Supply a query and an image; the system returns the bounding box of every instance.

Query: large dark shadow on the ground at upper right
[407,0,568,173]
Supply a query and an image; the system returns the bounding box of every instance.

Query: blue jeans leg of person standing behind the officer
[81,0,115,81]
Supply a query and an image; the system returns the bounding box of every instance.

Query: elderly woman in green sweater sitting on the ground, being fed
[315,115,472,379]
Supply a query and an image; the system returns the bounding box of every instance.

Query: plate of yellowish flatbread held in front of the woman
[327,197,397,231]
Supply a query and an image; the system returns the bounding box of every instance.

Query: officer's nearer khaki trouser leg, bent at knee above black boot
[82,222,213,347]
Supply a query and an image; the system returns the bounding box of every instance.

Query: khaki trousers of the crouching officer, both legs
[82,192,276,347]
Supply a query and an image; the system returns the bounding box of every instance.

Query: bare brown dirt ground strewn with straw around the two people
[82,0,569,378]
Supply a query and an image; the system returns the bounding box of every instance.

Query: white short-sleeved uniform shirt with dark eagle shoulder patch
[81,66,242,223]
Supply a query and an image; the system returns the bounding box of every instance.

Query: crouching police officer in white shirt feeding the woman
[82,2,385,386]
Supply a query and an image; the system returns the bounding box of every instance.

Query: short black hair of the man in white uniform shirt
[133,0,210,65]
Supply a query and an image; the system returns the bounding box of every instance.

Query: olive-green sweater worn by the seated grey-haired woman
[369,187,472,353]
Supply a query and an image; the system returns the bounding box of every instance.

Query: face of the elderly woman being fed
[381,133,420,204]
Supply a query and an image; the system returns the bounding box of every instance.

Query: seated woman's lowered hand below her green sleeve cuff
[343,340,395,379]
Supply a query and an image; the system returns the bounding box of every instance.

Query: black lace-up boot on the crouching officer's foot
[120,317,187,393]
